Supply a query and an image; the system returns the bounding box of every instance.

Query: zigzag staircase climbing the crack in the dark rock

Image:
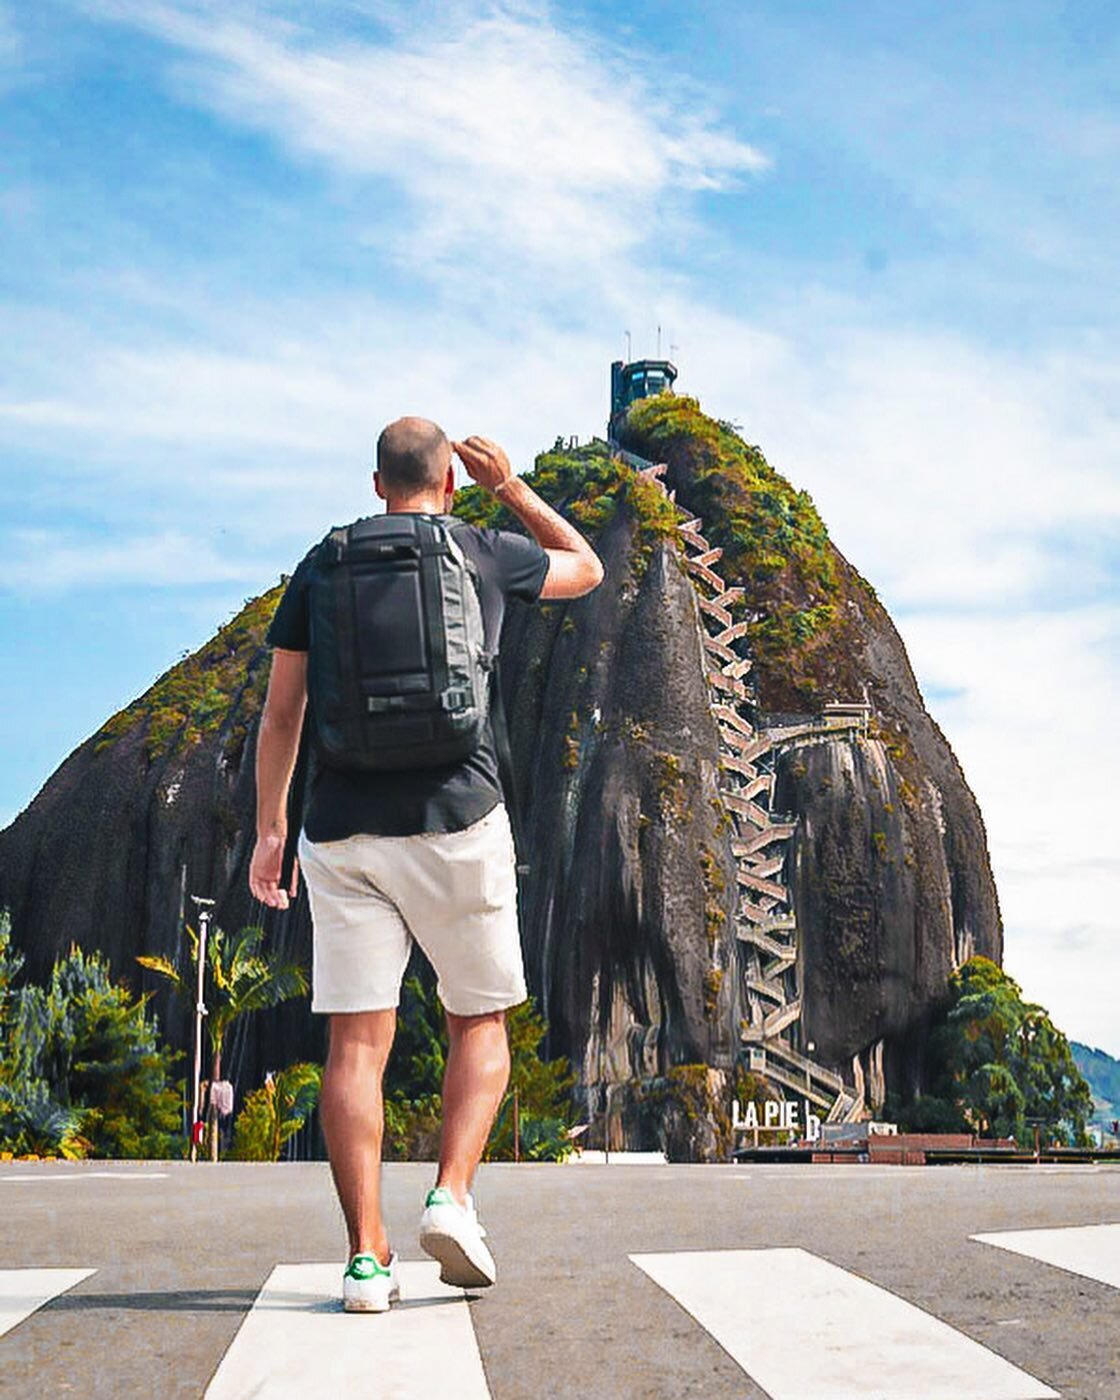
[610,442,867,1123]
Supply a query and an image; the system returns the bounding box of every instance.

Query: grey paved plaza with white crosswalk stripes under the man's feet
[0,1161,1120,1400]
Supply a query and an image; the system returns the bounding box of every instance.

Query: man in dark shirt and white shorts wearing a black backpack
[249,417,603,1312]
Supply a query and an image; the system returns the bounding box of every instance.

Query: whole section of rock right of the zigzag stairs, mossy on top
[624,395,1002,1110]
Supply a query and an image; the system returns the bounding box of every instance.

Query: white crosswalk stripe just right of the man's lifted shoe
[630,1249,1058,1400]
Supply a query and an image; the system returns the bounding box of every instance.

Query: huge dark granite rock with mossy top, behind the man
[0,406,1002,1147]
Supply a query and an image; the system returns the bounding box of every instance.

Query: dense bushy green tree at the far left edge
[0,920,181,1158]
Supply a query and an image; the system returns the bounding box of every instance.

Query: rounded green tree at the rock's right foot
[888,956,1092,1147]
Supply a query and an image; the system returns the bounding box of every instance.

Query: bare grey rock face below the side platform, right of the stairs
[776,700,1002,1103]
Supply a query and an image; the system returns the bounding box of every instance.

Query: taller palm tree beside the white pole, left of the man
[136,924,307,1162]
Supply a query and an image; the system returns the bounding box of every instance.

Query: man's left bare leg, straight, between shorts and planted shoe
[319,1007,396,1264]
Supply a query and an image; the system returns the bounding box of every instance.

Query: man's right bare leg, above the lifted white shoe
[435,1011,510,1205]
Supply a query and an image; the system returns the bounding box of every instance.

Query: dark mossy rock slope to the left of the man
[0,587,323,1092]
